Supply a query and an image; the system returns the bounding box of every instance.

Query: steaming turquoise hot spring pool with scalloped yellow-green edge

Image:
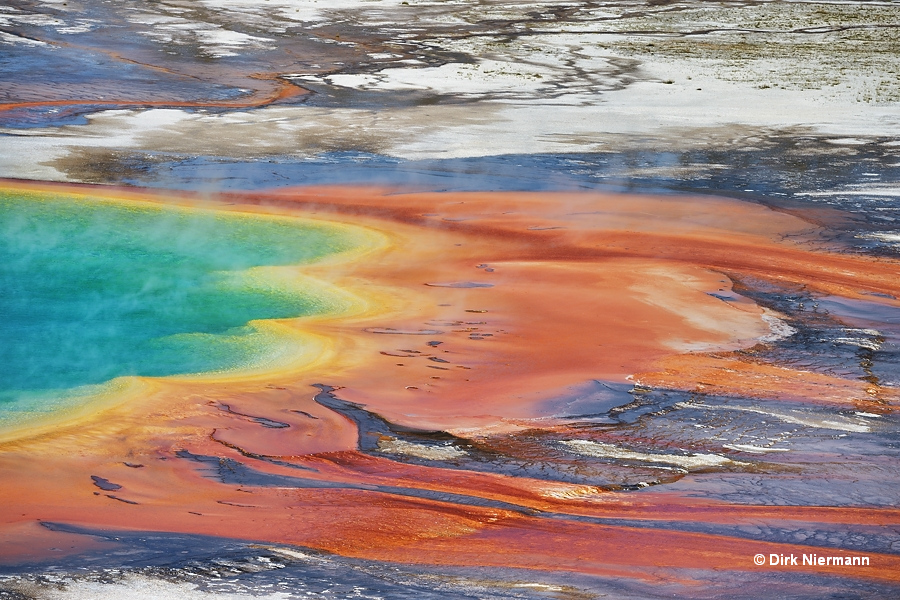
[0,191,360,421]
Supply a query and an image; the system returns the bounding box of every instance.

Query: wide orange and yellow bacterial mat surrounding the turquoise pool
[0,186,900,583]
